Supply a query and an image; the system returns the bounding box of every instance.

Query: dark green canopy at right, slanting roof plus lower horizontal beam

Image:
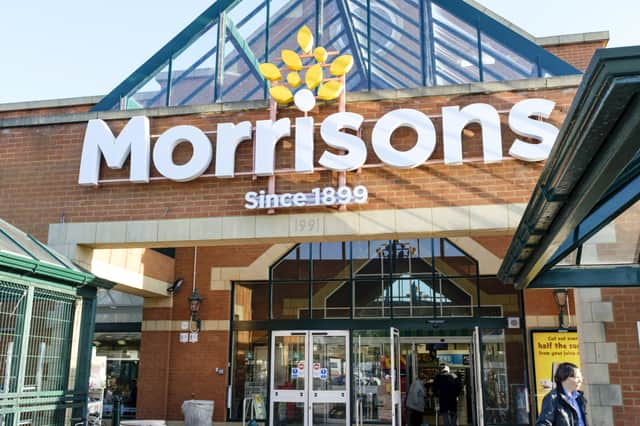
[498,46,640,289]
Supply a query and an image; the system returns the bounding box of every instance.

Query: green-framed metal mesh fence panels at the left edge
[0,280,78,426]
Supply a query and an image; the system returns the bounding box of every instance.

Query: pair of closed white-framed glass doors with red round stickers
[269,331,351,426]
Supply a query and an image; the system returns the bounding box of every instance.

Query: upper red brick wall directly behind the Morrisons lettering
[0,88,575,241]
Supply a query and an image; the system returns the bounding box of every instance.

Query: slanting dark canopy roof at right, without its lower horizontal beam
[498,47,640,289]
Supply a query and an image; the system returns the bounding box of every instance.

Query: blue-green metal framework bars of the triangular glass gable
[92,0,580,111]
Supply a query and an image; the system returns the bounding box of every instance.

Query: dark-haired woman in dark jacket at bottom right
[536,362,587,426]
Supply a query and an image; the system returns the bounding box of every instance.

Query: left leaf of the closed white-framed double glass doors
[269,331,308,426]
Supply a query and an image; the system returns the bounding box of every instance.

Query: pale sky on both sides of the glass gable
[0,0,640,103]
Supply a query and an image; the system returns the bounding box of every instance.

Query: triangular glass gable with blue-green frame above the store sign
[93,0,580,111]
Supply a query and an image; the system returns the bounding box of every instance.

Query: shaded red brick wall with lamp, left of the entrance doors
[137,245,269,421]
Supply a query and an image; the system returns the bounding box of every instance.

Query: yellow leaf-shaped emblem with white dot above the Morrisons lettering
[260,25,353,112]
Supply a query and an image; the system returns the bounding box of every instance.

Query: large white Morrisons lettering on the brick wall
[78,99,558,185]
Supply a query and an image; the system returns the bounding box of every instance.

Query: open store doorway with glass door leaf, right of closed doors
[353,329,484,425]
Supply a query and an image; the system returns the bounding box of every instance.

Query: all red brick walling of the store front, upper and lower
[0,36,640,425]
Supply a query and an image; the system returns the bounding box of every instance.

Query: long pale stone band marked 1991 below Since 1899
[48,203,524,250]
